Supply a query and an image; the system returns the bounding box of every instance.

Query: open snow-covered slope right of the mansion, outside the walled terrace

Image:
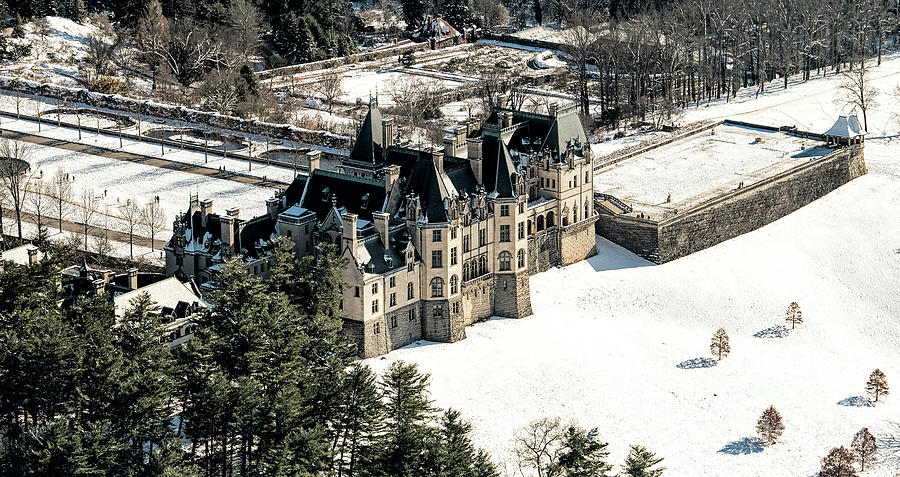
[367,57,900,476]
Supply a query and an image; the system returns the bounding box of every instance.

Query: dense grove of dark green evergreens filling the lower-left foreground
[0,236,498,477]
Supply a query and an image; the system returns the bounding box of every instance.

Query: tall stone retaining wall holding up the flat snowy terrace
[596,146,867,263]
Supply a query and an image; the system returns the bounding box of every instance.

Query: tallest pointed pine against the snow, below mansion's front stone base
[379,361,433,477]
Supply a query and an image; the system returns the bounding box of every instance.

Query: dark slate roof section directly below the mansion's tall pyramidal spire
[300,169,387,222]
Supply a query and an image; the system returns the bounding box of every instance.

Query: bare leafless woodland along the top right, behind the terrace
[544,0,898,125]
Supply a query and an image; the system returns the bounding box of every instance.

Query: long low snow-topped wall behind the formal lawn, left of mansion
[0,76,350,149]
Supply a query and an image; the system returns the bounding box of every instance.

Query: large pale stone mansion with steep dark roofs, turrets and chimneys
[165,100,597,357]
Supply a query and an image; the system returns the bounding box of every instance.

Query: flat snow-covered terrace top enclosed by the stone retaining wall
[594,123,829,218]
